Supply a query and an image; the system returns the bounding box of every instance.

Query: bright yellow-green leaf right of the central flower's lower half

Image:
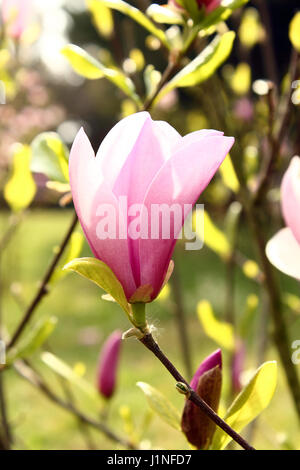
[193,210,231,259]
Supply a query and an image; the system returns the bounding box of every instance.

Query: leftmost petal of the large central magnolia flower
[69,129,137,298]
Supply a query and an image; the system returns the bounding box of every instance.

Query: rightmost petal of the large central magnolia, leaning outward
[139,135,234,298]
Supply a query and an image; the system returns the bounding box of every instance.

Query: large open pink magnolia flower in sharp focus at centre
[69,112,234,302]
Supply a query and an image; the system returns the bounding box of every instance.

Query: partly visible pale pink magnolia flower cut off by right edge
[266,157,300,280]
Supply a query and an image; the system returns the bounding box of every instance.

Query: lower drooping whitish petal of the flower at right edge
[266,228,300,280]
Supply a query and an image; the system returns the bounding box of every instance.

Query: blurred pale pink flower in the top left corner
[2,0,32,38]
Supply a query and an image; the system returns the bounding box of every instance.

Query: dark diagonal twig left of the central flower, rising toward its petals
[7,212,78,349]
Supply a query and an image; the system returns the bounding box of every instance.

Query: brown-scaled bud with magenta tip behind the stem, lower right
[181,349,222,450]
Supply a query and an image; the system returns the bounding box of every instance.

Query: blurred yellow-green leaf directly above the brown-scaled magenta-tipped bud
[197,300,234,351]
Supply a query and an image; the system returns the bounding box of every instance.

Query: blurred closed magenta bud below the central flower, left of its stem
[97,330,122,398]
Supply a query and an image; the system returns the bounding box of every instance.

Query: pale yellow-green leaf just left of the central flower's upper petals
[30,132,69,183]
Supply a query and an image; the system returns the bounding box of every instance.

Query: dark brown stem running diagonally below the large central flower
[139,333,255,450]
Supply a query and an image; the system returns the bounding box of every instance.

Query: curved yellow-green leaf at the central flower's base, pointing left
[64,258,130,315]
